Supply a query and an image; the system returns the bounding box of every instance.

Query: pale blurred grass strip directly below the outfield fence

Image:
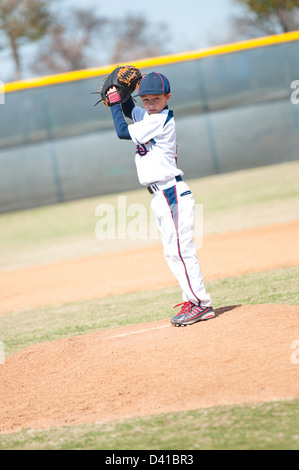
[0,162,299,270]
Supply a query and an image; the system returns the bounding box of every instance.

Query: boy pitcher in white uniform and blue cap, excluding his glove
[108,72,215,326]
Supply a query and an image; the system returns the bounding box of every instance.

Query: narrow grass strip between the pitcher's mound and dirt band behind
[0,267,299,357]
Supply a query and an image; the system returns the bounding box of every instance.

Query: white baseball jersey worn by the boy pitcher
[128,106,184,186]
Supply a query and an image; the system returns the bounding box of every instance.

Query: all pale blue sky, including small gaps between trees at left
[0,0,244,81]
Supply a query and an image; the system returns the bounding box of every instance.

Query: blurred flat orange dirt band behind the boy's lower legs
[0,221,299,314]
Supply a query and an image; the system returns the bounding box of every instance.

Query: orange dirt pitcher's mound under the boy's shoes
[0,305,299,433]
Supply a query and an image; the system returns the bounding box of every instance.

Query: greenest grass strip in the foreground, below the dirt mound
[0,400,299,451]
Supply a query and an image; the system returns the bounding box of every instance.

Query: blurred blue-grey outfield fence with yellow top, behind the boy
[0,31,299,212]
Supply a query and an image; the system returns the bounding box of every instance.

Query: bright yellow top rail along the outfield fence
[4,31,299,93]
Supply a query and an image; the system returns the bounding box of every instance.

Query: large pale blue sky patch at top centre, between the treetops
[63,0,238,52]
